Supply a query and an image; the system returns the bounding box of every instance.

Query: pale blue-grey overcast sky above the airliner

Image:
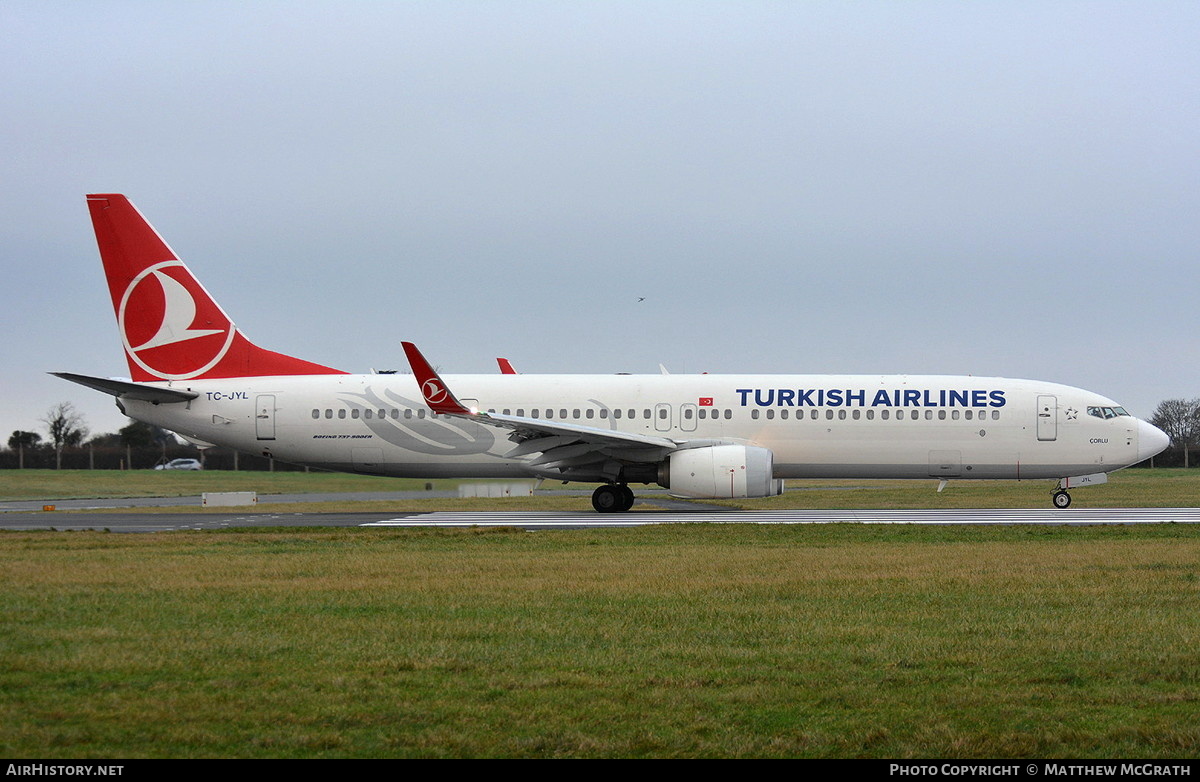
[0,0,1200,439]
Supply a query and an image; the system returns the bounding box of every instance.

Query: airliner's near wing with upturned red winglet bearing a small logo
[401,342,688,475]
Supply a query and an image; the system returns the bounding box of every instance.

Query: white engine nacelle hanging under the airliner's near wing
[659,445,784,499]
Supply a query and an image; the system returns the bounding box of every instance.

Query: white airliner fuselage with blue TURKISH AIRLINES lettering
[122,374,1140,479]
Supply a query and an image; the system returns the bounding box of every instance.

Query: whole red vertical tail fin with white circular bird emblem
[88,194,344,381]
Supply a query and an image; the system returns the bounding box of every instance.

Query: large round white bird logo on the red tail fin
[118,260,236,380]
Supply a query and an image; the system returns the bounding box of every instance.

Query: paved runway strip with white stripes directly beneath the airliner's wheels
[0,506,1200,533]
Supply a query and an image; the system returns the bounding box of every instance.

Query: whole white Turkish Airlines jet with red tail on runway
[53,194,1168,512]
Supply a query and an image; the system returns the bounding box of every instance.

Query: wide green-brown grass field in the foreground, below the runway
[0,525,1200,758]
